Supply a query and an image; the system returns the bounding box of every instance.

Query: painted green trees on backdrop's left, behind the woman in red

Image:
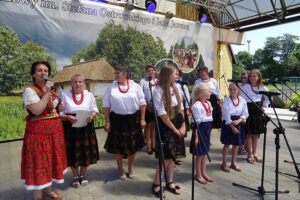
[0,26,56,95]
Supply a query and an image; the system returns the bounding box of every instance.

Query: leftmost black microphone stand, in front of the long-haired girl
[149,80,169,200]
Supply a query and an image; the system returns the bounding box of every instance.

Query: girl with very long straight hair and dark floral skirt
[152,65,185,197]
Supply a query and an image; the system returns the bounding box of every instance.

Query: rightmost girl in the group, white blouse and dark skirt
[245,69,270,164]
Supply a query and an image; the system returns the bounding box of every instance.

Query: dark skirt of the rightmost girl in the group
[245,102,264,135]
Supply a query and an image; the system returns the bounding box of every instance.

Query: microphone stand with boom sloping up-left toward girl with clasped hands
[232,81,289,199]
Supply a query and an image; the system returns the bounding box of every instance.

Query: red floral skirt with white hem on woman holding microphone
[21,118,67,190]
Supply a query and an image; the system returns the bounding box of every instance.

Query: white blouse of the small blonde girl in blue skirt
[191,101,213,123]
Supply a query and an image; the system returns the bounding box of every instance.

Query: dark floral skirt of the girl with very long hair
[155,113,185,161]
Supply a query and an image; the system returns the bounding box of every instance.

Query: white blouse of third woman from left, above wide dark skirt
[103,80,146,115]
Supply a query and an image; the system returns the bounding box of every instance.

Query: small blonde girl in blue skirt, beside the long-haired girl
[190,83,213,184]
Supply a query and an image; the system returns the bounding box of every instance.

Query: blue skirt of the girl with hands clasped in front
[220,116,245,146]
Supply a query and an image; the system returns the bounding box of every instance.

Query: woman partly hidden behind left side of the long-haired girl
[140,65,157,155]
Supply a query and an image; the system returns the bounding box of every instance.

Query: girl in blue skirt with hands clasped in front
[221,83,249,172]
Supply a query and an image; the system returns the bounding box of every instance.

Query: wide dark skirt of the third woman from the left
[104,112,146,159]
